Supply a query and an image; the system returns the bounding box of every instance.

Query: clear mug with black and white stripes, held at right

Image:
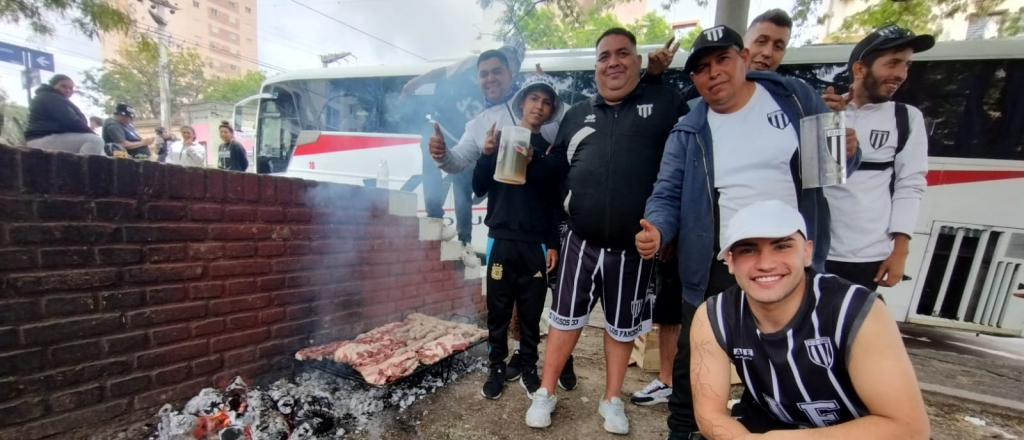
[800,112,846,189]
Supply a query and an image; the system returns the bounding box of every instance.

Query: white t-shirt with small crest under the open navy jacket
[708,84,799,247]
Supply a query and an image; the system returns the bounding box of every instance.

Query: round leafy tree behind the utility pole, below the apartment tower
[83,38,206,119]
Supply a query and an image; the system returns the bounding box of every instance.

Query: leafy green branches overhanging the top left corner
[0,0,135,38]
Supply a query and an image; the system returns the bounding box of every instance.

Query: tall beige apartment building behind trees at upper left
[102,0,258,77]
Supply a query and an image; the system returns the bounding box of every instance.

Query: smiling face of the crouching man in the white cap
[725,232,814,305]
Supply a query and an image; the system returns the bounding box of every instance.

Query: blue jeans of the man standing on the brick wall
[420,124,473,243]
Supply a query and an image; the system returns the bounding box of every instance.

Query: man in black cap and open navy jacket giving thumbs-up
[636,26,859,439]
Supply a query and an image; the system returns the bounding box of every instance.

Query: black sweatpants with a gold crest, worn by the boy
[487,238,548,370]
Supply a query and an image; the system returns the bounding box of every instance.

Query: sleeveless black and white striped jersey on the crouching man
[708,269,878,428]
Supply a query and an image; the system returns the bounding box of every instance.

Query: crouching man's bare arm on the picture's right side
[764,301,930,440]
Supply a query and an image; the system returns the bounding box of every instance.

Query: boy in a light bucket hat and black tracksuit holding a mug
[473,77,563,399]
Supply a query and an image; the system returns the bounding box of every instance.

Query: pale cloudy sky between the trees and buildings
[0,0,794,116]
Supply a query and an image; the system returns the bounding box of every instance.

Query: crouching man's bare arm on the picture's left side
[690,303,751,440]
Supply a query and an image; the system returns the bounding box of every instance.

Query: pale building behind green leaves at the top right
[818,0,1024,43]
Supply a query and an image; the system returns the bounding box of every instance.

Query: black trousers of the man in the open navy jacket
[669,260,736,434]
